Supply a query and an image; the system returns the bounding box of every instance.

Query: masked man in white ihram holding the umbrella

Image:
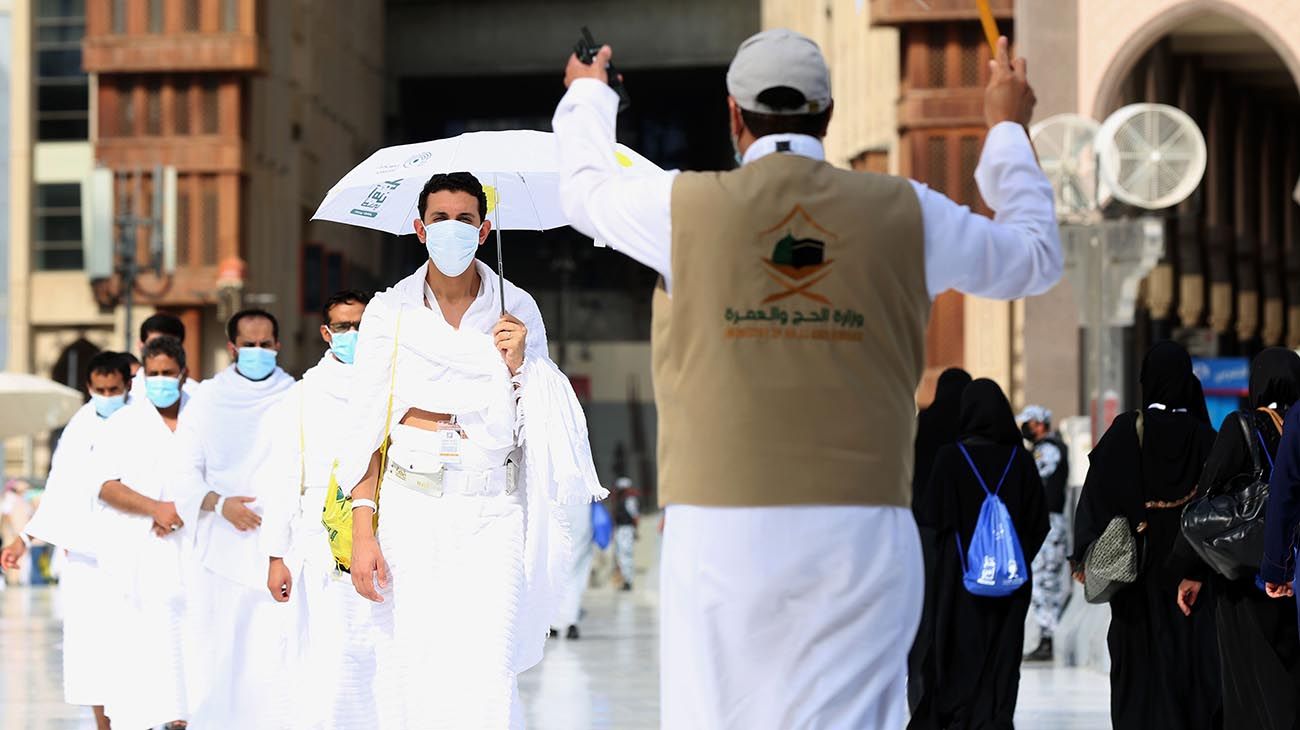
[337,173,606,730]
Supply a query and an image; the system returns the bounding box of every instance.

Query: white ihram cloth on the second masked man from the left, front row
[95,394,196,727]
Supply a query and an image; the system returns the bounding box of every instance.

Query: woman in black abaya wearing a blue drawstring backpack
[909,379,1048,730]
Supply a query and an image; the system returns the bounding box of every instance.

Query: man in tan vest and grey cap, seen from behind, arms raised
[554,30,1061,730]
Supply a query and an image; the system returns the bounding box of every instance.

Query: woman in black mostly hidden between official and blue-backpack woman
[907,368,971,709]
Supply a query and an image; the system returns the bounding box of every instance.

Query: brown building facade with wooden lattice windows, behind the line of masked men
[7,0,387,472]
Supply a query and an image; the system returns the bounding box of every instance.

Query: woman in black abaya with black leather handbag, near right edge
[1177,347,1300,730]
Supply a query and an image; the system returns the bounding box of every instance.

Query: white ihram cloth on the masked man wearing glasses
[261,352,376,730]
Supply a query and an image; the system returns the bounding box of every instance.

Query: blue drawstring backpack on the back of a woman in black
[957,444,1026,598]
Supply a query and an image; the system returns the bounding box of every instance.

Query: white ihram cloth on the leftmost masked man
[22,403,116,705]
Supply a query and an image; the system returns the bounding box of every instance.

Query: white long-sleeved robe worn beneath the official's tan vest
[551,79,1062,730]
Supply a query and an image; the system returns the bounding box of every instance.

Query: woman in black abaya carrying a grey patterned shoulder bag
[1071,342,1221,730]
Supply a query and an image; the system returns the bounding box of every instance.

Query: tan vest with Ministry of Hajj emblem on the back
[651,153,931,507]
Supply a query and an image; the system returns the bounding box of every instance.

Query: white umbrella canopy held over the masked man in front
[312,130,659,235]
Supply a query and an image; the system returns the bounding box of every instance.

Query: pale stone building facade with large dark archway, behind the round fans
[1015,0,1300,413]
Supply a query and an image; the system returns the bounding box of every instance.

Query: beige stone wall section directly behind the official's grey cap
[762,0,898,170]
